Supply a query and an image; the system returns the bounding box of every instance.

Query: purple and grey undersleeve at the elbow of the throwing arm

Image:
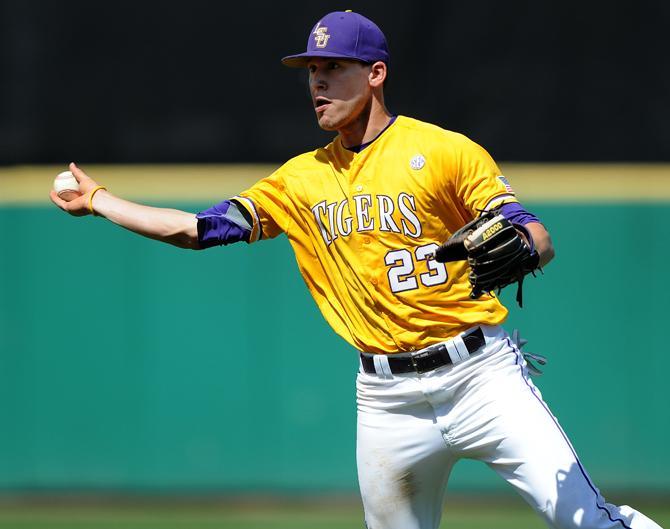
[195,200,253,248]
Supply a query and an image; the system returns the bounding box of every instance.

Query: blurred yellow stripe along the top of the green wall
[0,163,670,205]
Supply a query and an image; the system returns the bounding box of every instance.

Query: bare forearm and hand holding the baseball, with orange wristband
[50,163,201,250]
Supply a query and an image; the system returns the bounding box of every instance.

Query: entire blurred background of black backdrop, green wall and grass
[0,0,670,529]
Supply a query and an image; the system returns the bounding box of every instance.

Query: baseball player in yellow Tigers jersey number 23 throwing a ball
[51,11,659,529]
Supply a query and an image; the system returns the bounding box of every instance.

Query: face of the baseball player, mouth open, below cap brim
[307,57,372,130]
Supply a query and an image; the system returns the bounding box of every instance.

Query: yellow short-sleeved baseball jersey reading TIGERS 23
[235,116,516,353]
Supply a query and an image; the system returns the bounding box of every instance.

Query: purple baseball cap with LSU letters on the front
[281,11,390,68]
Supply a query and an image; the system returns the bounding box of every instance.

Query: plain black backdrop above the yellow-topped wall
[0,0,670,164]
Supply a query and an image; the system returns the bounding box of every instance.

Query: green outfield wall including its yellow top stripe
[0,164,670,494]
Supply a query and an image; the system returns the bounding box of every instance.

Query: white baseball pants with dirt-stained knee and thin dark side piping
[356,326,660,529]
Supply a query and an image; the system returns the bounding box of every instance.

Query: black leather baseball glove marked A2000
[434,208,540,307]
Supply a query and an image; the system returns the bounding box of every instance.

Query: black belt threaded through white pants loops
[360,327,486,374]
